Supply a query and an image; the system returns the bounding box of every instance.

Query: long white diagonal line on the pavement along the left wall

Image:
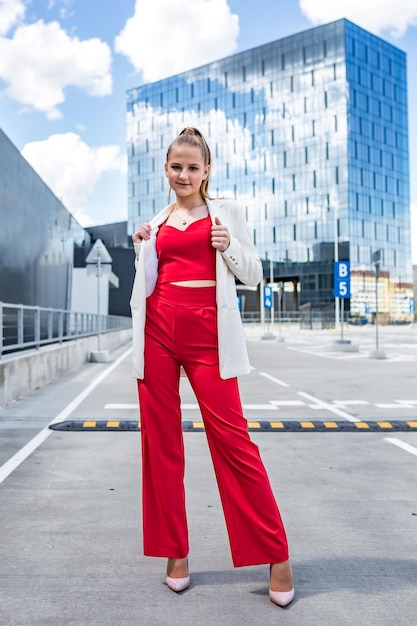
[0,348,132,484]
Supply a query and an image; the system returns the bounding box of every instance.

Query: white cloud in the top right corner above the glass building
[299,0,417,37]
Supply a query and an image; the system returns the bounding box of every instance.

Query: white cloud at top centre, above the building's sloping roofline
[115,0,239,82]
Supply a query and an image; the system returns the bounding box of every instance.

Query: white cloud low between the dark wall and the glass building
[22,133,126,225]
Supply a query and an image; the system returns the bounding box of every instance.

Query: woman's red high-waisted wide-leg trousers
[138,284,288,567]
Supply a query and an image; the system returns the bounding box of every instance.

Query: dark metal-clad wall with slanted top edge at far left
[0,130,89,309]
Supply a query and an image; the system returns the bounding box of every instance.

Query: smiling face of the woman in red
[165,145,210,201]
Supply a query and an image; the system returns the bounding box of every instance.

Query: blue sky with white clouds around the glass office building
[0,0,417,263]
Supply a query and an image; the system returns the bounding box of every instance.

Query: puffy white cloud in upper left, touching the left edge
[0,19,112,119]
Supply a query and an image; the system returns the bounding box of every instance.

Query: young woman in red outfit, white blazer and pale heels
[131,128,294,606]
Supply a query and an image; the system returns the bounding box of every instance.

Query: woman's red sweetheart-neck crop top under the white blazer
[156,215,216,283]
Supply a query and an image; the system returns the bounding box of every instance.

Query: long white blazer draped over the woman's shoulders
[130,199,263,378]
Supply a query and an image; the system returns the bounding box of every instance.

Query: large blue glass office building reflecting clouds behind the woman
[127,19,412,320]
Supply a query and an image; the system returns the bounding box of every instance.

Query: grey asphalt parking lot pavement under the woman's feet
[0,326,417,626]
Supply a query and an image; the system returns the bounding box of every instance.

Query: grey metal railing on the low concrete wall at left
[0,302,132,358]
